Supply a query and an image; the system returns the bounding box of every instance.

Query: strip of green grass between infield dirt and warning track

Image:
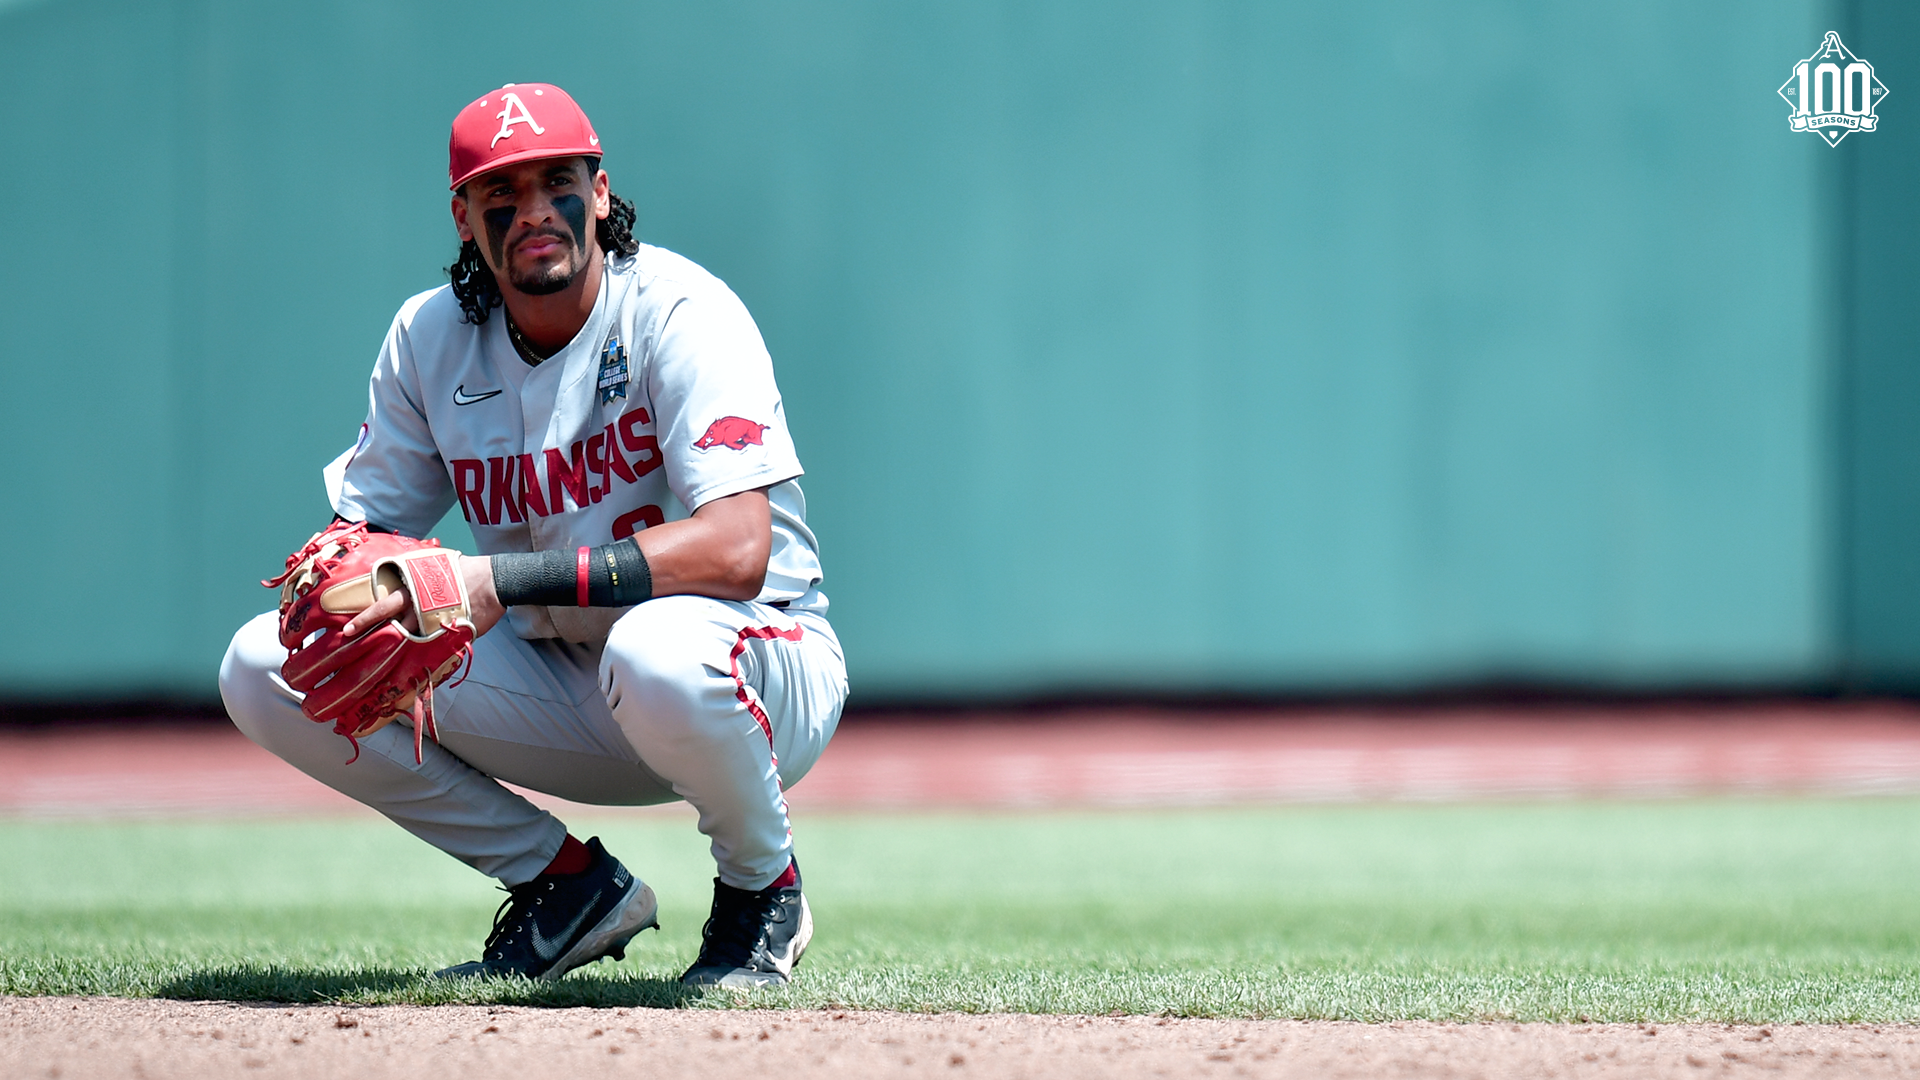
[0,799,1920,1022]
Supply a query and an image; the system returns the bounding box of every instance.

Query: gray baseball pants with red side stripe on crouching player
[221,596,847,890]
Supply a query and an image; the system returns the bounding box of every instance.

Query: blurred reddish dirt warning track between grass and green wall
[0,701,1920,817]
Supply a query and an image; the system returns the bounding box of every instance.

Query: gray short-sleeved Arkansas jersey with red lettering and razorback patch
[326,246,828,642]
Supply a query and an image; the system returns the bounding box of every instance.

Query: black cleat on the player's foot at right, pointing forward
[680,863,814,990]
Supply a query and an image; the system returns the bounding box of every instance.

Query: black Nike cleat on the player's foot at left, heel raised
[434,836,660,980]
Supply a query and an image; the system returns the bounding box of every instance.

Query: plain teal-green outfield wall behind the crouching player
[0,0,1920,701]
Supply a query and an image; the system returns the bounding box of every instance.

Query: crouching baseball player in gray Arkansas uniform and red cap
[221,83,847,988]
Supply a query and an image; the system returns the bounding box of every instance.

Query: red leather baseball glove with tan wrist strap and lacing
[261,521,474,763]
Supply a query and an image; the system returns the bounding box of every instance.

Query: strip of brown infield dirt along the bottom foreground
[0,997,1920,1080]
